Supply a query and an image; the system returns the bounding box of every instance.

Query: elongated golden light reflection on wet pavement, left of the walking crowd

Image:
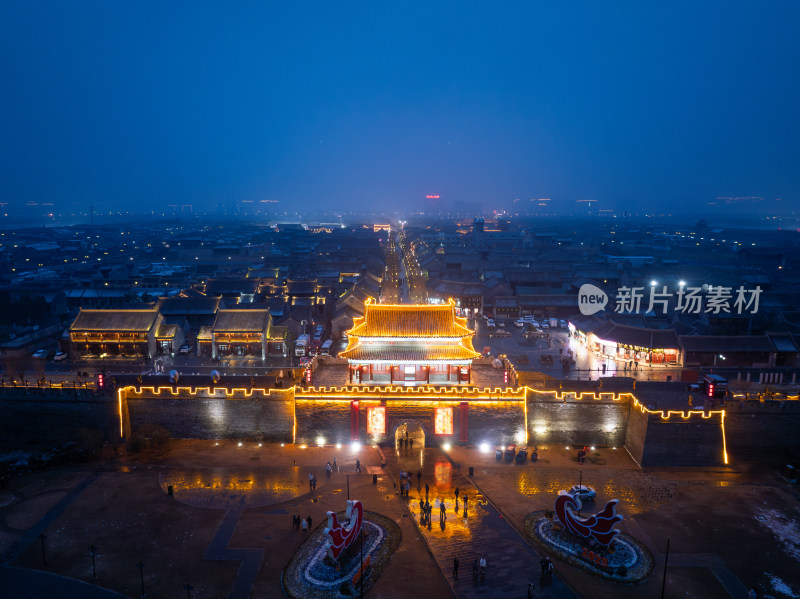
[159,468,322,508]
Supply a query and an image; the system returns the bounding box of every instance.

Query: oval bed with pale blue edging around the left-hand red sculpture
[281,511,402,599]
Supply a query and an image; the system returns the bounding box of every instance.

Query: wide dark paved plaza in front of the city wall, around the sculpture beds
[0,441,800,599]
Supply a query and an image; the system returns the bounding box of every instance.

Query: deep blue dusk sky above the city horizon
[0,0,800,211]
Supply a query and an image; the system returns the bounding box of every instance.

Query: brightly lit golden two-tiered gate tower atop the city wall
[339,299,480,386]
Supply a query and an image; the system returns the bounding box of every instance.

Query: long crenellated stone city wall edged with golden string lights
[0,385,752,474]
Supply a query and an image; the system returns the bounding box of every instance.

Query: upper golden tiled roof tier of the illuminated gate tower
[347,300,474,337]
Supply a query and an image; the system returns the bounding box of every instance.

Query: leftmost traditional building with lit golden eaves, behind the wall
[69,308,165,357]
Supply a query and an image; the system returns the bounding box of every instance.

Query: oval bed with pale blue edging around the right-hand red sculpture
[525,510,655,582]
